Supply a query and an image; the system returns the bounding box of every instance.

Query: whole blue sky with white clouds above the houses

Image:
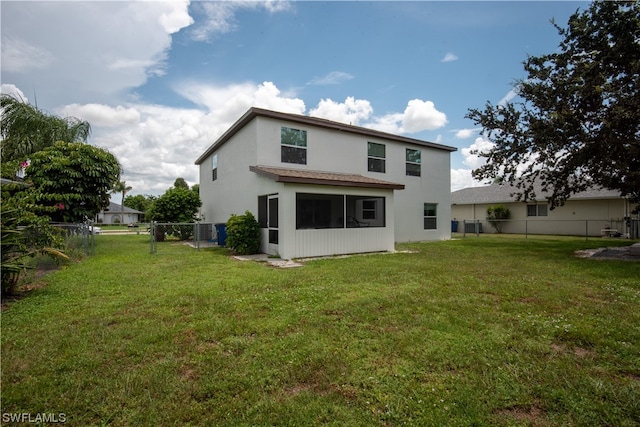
[0,1,588,197]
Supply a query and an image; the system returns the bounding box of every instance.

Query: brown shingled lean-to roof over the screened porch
[249,166,404,190]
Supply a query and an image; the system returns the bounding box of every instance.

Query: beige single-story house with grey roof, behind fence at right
[451,184,637,236]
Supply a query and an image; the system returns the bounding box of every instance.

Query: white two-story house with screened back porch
[195,108,456,259]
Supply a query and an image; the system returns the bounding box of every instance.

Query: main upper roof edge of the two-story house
[195,107,457,165]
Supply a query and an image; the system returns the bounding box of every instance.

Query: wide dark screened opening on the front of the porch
[296,193,386,230]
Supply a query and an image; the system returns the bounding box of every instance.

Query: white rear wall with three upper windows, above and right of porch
[254,117,451,242]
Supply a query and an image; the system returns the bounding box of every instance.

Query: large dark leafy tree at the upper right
[466,1,640,209]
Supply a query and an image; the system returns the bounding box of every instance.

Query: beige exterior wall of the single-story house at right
[451,198,629,236]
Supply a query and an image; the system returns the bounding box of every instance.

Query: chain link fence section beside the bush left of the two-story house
[149,222,218,254]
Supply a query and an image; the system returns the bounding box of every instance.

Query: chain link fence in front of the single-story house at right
[452,218,640,239]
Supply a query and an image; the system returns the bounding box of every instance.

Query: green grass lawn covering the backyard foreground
[1,235,640,426]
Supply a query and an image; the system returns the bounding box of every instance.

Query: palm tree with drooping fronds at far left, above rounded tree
[0,94,91,169]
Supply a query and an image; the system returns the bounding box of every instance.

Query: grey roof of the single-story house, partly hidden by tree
[451,184,621,205]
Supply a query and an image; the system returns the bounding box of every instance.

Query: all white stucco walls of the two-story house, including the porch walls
[200,116,451,259]
